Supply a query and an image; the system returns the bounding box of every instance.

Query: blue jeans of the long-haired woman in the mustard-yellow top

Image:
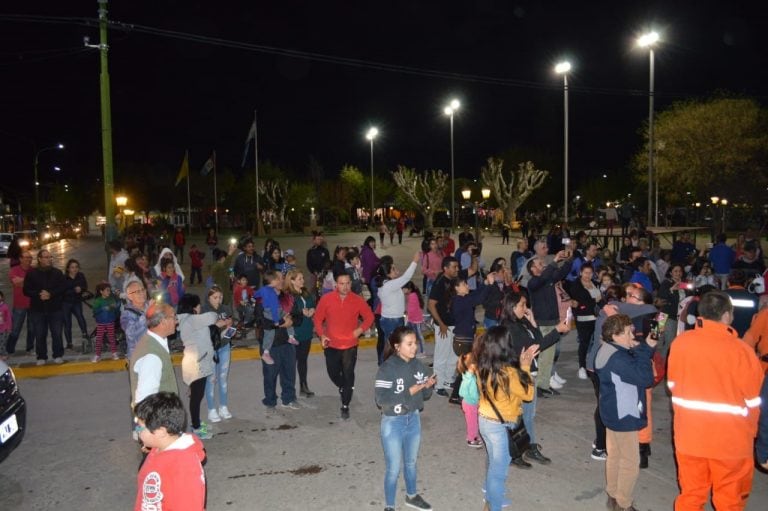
[479,415,517,511]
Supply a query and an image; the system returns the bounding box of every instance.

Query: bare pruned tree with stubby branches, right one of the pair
[480,157,549,222]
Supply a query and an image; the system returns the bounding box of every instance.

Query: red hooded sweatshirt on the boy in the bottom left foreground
[133,433,206,511]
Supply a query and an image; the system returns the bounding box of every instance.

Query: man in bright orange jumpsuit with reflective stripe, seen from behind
[667,291,763,511]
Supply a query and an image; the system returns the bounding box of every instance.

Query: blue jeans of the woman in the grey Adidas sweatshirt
[381,410,421,507]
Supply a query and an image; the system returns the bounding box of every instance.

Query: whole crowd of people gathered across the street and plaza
[0,227,768,511]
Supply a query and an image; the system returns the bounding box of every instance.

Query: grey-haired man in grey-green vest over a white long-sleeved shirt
[128,303,179,406]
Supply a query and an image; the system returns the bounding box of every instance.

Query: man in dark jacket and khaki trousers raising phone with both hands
[526,250,573,397]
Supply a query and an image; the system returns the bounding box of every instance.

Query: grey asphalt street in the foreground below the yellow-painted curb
[0,234,768,511]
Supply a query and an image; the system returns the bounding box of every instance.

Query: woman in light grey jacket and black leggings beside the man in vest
[177,294,220,440]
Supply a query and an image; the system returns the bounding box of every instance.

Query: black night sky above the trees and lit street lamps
[0,0,768,206]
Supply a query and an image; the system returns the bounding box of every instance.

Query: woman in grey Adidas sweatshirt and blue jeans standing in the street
[374,326,436,511]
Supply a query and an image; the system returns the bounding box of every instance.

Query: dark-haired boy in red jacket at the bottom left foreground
[134,392,206,511]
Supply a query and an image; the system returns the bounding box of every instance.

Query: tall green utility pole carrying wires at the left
[85,0,117,241]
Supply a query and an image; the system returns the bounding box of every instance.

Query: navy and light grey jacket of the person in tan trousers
[595,342,653,431]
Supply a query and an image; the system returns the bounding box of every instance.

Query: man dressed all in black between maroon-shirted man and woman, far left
[24,249,66,365]
